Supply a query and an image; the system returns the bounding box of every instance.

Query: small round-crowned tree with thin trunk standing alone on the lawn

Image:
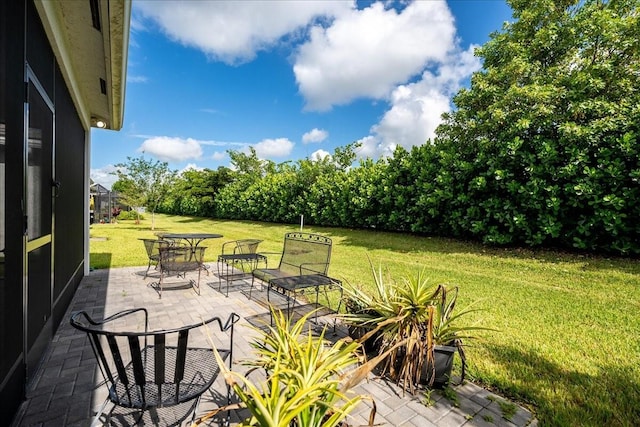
[113,156,176,230]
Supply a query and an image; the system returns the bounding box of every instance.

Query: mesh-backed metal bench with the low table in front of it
[249,232,342,329]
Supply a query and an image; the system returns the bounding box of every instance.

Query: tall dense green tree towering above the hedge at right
[435,0,640,254]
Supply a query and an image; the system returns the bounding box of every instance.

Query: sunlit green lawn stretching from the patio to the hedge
[90,215,640,426]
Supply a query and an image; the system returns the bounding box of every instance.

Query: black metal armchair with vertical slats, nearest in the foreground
[70,308,240,425]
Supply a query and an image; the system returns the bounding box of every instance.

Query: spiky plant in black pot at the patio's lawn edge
[342,261,486,393]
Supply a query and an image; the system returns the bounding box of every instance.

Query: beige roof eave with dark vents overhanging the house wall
[35,0,131,130]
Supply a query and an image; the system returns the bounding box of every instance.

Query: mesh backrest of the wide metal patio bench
[278,232,331,275]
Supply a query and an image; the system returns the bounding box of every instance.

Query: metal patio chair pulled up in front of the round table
[157,243,206,298]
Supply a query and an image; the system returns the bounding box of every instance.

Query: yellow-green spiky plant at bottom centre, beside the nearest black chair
[196,311,390,427]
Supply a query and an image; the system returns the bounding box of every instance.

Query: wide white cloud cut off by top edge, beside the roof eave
[134,0,354,64]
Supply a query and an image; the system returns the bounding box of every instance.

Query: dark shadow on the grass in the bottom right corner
[486,345,640,426]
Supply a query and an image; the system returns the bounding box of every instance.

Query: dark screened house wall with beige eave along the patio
[0,0,131,424]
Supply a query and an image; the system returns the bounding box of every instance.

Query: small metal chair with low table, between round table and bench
[218,239,267,296]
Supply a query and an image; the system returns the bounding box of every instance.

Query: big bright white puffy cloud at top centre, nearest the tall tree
[293,1,455,111]
